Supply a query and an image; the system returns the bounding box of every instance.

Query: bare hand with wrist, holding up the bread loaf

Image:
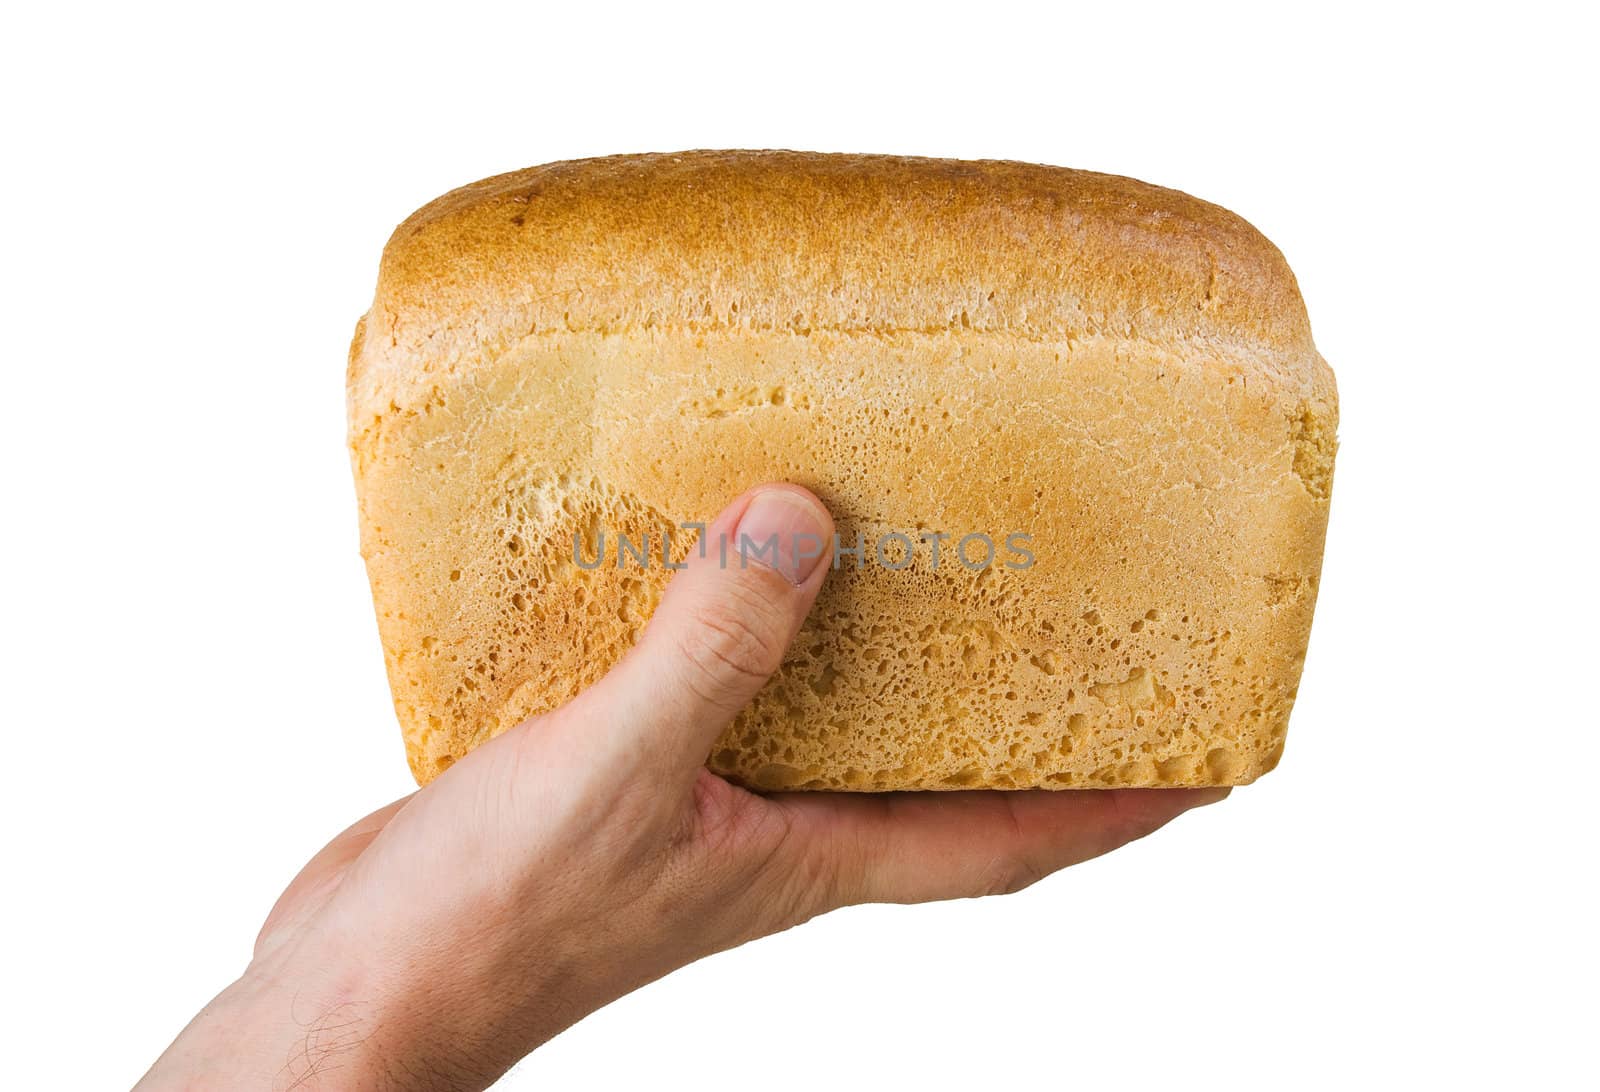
[139,485,1227,1090]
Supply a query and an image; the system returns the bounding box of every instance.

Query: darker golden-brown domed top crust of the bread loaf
[349,151,1320,432]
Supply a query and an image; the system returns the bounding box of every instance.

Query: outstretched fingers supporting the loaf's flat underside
[781,788,1229,906]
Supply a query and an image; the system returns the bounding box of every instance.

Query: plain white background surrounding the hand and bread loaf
[0,2,1600,1089]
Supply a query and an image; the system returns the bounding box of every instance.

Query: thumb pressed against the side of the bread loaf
[574,485,834,773]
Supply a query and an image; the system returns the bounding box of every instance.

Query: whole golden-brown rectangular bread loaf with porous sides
[349,152,1338,789]
